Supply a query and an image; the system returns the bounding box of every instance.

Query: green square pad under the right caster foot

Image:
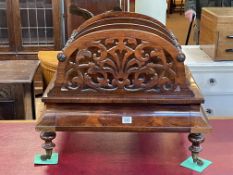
[180,156,212,173]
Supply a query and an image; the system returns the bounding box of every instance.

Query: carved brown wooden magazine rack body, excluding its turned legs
[37,12,211,165]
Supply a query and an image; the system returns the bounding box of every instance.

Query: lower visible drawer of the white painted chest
[203,94,233,117]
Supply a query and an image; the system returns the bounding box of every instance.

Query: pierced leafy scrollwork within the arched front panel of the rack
[62,37,179,92]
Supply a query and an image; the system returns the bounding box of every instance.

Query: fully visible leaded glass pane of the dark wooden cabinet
[19,0,54,47]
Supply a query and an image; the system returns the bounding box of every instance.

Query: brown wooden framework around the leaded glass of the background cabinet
[0,0,62,60]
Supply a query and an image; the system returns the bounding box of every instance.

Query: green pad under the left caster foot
[34,152,58,165]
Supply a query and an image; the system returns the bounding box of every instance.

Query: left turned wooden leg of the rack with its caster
[40,132,56,160]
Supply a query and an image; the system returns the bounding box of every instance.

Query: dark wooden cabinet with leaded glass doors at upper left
[0,0,62,60]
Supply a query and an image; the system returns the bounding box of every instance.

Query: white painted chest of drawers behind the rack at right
[182,46,233,118]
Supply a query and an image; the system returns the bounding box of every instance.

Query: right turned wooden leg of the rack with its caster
[188,133,205,166]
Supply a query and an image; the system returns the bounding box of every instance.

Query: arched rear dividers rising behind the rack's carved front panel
[65,12,181,53]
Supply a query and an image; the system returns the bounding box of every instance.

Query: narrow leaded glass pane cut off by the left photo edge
[0,0,9,47]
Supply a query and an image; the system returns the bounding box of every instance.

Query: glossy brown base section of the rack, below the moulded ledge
[37,104,211,133]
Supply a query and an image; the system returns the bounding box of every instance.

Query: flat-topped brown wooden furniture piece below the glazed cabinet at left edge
[0,60,39,120]
